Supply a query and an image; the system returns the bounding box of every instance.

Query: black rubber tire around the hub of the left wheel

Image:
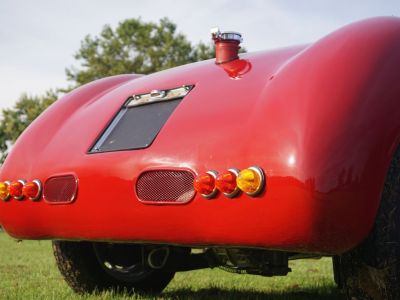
[53,241,175,294]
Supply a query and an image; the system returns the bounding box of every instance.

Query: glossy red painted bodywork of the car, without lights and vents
[0,17,400,254]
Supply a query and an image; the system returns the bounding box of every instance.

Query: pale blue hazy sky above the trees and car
[0,0,400,109]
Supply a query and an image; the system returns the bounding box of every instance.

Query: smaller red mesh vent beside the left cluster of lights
[43,175,78,203]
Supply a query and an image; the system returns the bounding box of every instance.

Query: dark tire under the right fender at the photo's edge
[335,147,400,300]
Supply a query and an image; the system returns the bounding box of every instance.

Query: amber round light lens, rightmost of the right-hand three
[236,167,265,196]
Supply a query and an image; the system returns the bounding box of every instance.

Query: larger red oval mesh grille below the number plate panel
[136,170,195,203]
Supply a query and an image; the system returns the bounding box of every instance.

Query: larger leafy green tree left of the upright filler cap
[66,18,214,85]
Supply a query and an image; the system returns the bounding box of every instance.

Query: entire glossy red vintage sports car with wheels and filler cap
[0,17,400,299]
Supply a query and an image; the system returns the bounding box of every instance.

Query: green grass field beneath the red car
[0,232,341,300]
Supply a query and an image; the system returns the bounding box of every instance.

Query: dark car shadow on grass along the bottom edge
[161,287,345,300]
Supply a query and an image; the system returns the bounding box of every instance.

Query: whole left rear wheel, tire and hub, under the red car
[53,241,174,293]
